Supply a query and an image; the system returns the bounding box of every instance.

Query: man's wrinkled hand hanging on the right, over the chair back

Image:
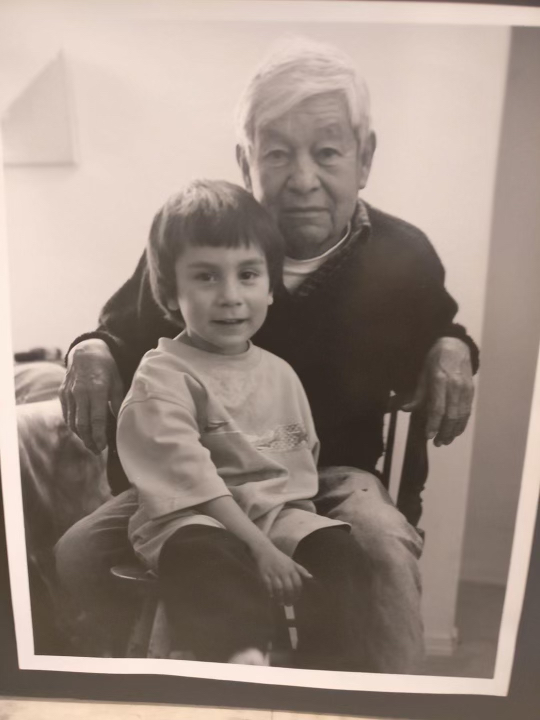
[402,337,474,447]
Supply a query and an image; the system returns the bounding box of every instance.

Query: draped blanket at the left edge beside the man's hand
[8,362,110,654]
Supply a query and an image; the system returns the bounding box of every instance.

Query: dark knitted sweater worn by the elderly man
[70,203,478,490]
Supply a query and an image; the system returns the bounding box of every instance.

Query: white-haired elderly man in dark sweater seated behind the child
[57,42,478,673]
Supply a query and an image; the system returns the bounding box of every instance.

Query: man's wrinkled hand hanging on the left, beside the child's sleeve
[60,338,124,455]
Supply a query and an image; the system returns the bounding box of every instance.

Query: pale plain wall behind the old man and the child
[0,2,508,645]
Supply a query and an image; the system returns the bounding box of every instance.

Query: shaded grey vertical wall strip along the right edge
[462,28,540,584]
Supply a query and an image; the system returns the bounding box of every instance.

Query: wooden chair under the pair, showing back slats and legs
[111,399,428,665]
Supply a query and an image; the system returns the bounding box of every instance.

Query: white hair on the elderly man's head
[236,36,371,153]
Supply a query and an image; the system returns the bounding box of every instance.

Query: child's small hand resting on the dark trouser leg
[255,545,313,605]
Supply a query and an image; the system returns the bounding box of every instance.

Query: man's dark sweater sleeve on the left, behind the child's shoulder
[66,252,182,388]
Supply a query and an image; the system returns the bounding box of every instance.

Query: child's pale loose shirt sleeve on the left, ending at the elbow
[117,395,231,519]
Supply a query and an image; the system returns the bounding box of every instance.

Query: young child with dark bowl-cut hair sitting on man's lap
[118,181,372,670]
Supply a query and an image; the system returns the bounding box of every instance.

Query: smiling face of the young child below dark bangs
[169,245,272,355]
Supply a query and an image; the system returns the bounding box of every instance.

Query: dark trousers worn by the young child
[159,525,370,671]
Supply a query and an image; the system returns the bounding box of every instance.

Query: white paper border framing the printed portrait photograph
[0,0,540,696]
